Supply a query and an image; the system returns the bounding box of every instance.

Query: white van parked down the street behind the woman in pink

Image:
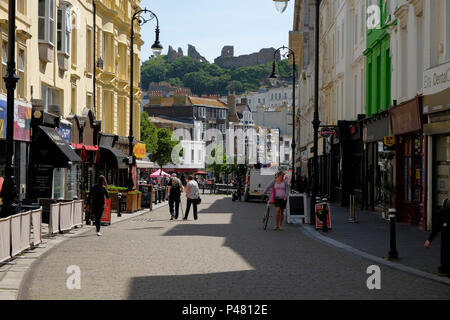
[244,167,278,202]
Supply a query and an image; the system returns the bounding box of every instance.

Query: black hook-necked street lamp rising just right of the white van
[269,46,297,191]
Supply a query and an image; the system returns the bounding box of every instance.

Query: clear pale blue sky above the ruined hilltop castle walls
[141,0,295,63]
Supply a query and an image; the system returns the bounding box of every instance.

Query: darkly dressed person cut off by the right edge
[425,199,450,278]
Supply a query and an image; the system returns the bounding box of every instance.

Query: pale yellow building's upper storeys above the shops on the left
[0,0,143,139]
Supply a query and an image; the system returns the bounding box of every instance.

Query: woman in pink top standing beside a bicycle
[264,171,290,230]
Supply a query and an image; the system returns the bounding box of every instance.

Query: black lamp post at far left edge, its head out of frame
[0,0,20,217]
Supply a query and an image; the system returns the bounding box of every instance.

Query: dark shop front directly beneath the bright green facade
[362,111,395,211]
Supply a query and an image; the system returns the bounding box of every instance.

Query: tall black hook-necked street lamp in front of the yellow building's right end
[128,9,163,191]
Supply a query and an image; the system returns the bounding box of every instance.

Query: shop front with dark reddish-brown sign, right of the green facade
[389,96,427,229]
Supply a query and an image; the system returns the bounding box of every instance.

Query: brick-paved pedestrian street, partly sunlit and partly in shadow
[19,195,450,300]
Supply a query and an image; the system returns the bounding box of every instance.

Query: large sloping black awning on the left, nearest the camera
[32,126,82,168]
